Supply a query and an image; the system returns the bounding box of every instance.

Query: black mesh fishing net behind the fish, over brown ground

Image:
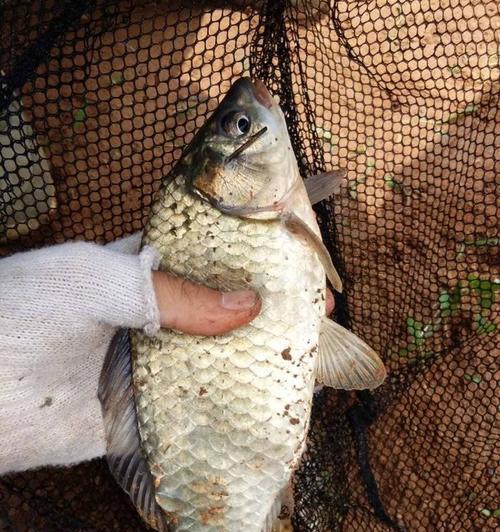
[0,0,500,531]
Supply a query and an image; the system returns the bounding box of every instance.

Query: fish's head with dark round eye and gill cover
[181,78,301,219]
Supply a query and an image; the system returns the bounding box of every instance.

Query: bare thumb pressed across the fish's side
[153,271,261,336]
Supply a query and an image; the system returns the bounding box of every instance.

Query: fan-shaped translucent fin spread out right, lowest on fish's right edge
[316,317,386,390]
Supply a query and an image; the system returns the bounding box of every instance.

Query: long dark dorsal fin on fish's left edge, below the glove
[98,329,169,532]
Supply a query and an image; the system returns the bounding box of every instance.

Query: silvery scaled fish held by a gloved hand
[99,78,386,532]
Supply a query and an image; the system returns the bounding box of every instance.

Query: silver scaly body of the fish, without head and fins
[131,176,325,532]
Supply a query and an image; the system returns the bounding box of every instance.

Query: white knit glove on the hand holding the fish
[0,237,159,474]
